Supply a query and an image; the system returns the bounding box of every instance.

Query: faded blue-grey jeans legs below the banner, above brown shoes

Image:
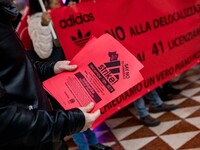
[134,90,163,118]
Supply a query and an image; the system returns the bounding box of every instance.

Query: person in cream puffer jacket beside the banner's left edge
[28,0,65,61]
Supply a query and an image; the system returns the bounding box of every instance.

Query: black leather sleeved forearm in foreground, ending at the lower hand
[0,96,85,146]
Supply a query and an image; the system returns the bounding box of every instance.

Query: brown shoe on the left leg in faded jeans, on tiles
[140,115,160,127]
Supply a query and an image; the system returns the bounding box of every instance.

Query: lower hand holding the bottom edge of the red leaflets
[79,103,101,132]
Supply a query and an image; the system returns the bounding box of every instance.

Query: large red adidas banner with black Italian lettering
[51,0,200,127]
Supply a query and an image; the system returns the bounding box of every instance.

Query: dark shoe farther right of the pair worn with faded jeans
[149,103,176,113]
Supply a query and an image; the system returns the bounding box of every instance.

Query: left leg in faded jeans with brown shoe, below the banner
[133,97,160,127]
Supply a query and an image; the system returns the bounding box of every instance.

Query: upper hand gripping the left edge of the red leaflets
[54,60,77,74]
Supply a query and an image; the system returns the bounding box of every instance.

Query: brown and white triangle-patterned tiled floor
[68,65,200,150]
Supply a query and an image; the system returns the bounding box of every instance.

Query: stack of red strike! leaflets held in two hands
[43,34,143,111]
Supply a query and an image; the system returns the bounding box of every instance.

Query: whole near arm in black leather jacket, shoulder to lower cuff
[0,22,83,146]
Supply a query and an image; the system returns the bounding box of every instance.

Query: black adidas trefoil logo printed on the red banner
[71,29,91,47]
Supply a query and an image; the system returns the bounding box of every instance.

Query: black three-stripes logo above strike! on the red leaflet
[104,52,120,80]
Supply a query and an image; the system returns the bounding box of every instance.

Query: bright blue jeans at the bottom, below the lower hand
[72,129,98,150]
